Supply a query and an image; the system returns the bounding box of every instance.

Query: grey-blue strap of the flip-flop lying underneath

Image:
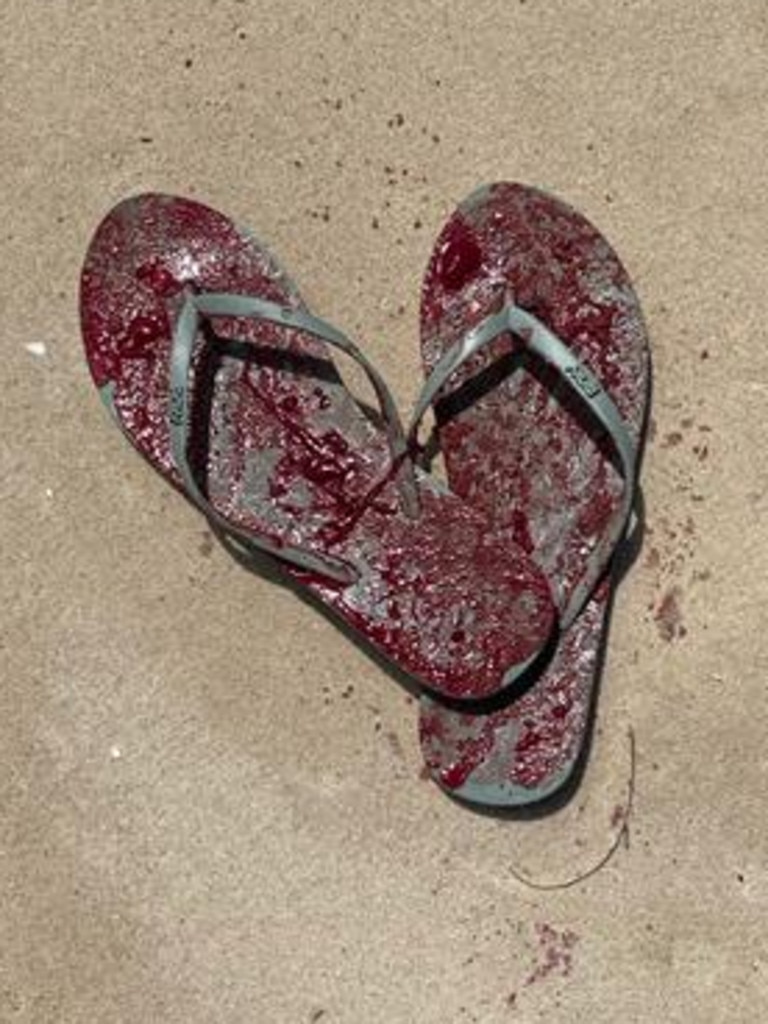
[407,302,637,630]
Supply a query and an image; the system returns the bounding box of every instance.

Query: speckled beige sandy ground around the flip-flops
[0,0,768,1024]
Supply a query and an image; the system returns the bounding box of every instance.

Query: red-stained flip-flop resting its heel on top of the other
[81,195,554,699]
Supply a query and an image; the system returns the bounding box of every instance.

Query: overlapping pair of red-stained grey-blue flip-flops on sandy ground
[81,184,649,806]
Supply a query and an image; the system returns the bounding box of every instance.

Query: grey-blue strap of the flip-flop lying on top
[168,293,418,583]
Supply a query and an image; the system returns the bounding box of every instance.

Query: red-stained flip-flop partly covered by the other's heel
[420,183,650,807]
